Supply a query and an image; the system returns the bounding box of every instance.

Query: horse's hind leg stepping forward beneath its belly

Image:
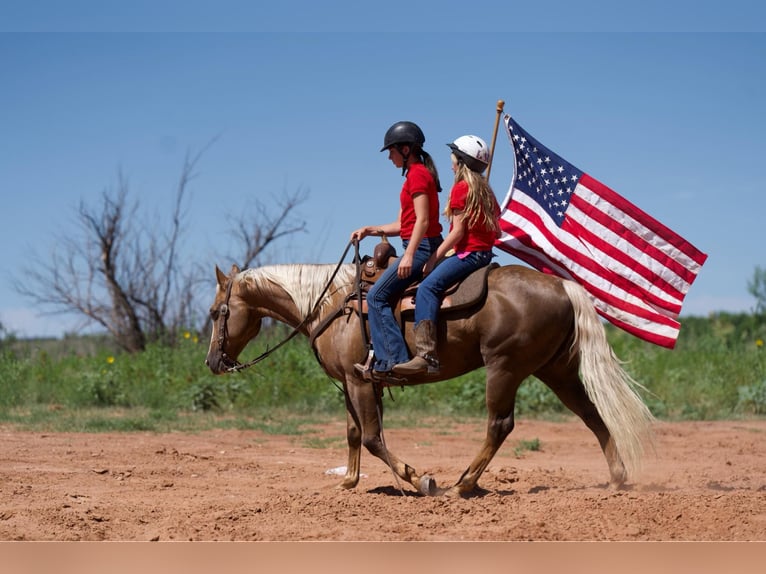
[445,359,521,496]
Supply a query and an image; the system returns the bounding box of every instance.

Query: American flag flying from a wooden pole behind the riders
[497,116,707,348]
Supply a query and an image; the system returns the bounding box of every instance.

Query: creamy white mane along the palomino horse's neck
[240,263,354,317]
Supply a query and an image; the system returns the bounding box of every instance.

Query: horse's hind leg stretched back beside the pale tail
[535,366,628,489]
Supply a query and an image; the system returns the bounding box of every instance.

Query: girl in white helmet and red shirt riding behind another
[392,135,500,377]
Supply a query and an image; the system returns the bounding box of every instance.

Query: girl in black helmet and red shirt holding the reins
[351,122,442,377]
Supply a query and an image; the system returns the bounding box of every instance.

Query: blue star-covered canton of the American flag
[507,118,583,227]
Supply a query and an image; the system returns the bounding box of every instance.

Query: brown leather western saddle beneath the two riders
[348,240,499,320]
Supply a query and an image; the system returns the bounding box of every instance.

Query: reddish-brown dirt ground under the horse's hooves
[0,420,766,541]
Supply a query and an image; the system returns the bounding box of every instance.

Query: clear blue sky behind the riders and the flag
[0,27,766,336]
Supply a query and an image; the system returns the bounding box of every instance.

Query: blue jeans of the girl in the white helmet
[415,251,492,325]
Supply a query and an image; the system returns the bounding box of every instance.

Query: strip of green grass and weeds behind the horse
[0,315,766,436]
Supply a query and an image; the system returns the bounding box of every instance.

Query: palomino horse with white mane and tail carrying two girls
[205,258,653,496]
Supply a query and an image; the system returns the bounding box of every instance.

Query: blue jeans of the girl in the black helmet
[367,235,442,372]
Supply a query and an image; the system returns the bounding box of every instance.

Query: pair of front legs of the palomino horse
[348,381,437,496]
